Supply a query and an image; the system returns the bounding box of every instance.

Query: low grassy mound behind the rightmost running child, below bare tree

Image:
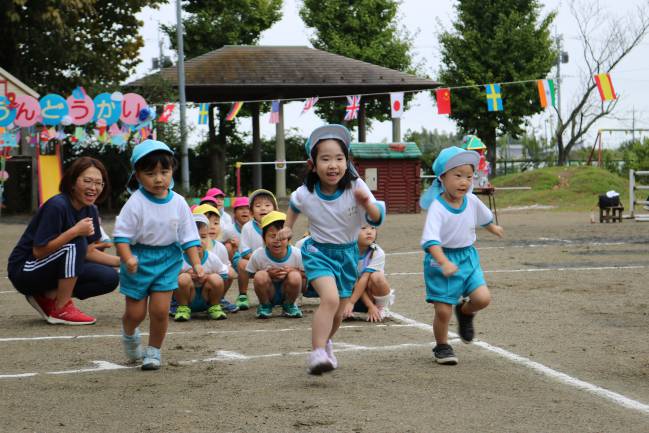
[492,167,629,211]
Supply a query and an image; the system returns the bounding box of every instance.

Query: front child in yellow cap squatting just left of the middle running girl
[246,211,303,319]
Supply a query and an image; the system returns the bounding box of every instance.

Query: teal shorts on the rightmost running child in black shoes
[424,245,487,305]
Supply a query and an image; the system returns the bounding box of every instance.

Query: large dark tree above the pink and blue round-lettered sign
[0,0,163,94]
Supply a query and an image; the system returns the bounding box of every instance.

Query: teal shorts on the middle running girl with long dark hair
[301,238,360,298]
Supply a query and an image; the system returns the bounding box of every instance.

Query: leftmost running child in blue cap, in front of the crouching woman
[114,140,205,370]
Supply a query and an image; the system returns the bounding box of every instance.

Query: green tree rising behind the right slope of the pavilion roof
[300,0,415,130]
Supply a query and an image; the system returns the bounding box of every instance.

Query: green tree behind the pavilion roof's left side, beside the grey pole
[162,0,282,186]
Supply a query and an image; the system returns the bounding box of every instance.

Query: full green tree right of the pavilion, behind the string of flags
[439,0,556,172]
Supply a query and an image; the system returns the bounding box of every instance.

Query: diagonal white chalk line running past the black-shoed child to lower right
[392,312,649,415]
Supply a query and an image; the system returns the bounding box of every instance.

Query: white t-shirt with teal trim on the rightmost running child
[421,194,493,249]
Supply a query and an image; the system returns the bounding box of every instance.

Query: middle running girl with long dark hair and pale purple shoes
[280,125,384,375]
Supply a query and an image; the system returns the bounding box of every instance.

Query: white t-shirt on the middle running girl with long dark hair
[290,178,385,244]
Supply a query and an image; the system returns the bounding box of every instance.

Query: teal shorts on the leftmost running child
[119,244,183,301]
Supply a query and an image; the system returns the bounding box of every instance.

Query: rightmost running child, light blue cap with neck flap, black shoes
[420,146,504,365]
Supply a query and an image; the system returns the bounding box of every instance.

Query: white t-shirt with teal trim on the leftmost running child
[113,188,200,249]
